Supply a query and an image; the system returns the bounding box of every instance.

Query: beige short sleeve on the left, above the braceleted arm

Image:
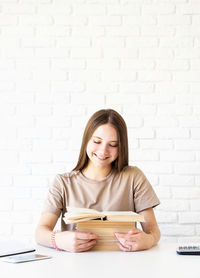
[43,175,63,217]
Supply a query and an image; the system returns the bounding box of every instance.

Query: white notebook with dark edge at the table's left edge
[0,239,35,257]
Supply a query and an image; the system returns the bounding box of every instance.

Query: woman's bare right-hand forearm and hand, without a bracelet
[115,208,160,251]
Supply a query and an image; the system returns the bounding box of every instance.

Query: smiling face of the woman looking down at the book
[86,124,119,167]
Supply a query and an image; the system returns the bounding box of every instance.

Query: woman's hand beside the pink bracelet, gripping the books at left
[55,231,98,252]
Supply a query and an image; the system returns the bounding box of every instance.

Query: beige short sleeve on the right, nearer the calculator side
[133,167,160,212]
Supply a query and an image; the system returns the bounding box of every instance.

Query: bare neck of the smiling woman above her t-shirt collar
[82,164,112,181]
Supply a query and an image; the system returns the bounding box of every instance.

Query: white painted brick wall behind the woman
[0,0,200,242]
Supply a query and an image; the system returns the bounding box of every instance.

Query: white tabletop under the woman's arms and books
[0,243,200,278]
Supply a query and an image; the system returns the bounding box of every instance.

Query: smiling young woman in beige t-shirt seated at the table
[36,109,160,252]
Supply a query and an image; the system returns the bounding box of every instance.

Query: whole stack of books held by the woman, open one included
[64,207,144,251]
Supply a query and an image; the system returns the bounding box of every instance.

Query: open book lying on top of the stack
[63,207,144,224]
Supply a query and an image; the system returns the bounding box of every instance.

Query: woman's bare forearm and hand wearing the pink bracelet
[35,213,98,252]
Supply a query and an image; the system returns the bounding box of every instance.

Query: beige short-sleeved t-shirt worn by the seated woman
[43,166,160,230]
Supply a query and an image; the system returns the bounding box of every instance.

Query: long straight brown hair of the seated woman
[73,109,128,172]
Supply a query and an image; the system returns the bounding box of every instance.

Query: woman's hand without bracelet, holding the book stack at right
[114,229,154,252]
